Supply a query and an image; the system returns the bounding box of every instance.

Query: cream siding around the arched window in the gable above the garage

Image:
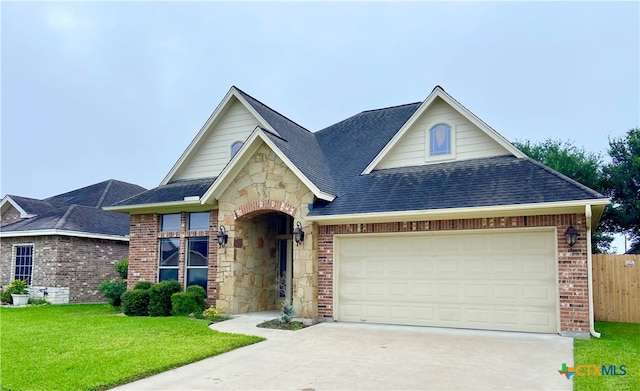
[376,98,509,169]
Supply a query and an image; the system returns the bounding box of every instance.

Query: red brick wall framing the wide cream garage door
[317,214,589,334]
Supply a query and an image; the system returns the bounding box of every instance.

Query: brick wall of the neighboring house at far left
[0,235,129,304]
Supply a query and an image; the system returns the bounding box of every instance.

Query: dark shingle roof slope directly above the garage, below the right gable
[309,156,604,216]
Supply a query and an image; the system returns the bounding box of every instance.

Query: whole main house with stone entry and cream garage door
[105,87,609,335]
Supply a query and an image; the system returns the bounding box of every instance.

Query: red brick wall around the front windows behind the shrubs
[127,209,218,305]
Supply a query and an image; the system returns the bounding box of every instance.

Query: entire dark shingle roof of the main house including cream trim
[107,86,609,222]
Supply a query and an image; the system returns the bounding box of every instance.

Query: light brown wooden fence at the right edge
[593,254,640,323]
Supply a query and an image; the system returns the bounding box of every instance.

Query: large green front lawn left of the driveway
[0,304,264,391]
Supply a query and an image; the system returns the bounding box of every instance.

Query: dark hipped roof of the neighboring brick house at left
[0,179,145,240]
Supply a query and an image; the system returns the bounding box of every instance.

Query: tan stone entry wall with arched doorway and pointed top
[218,144,318,318]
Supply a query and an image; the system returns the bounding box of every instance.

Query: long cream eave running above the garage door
[305,198,610,225]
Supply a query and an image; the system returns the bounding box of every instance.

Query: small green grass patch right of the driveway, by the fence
[573,322,640,391]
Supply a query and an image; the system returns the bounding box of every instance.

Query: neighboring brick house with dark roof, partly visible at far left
[0,179,146,304]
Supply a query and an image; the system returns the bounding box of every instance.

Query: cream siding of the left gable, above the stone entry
[171,99,259,180]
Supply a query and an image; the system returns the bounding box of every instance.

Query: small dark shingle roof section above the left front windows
[113,178,216,206]
